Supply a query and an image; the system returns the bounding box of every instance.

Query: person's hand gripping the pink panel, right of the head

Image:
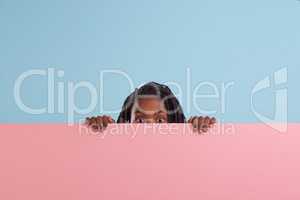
[188,116,216,133]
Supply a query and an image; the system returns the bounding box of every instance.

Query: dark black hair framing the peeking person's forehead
[117,82,185,123]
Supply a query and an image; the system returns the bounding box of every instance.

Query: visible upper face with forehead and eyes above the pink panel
[131,96,168,123]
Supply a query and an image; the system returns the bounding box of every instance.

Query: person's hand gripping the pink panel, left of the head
[85,115,115,131]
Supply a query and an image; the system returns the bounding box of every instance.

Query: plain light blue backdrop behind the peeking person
[0,0,300,123]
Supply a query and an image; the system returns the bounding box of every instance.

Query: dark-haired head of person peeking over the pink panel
[117,82,185,123]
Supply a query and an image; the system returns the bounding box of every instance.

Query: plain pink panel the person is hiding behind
[0,124,300,200]
